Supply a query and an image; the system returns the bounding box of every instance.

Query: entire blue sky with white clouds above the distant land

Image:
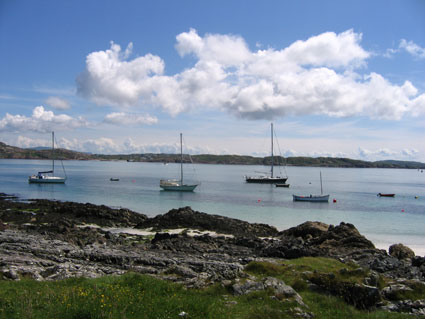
[0,0,425,162]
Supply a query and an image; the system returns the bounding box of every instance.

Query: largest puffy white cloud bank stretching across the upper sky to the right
[77,29,425,120]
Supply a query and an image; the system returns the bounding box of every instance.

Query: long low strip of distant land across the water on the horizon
[0,142,425,169]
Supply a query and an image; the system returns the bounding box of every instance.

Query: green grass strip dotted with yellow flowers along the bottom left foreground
[0,274,298,319]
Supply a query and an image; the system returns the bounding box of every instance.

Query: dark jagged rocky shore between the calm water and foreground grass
[0,194,425,318]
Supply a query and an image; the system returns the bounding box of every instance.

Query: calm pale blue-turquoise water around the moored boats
[0,160,425,256]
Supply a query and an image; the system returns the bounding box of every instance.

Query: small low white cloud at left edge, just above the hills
[0,106,89,133]
